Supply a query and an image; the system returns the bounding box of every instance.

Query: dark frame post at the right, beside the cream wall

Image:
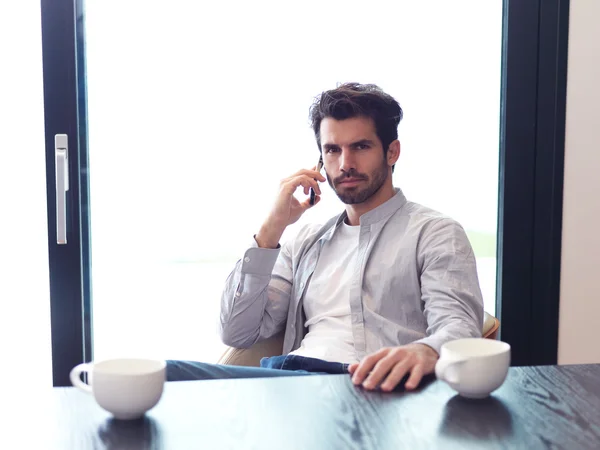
[496,0,569,366]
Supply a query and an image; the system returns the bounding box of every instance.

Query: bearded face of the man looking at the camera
[321,117,390,205]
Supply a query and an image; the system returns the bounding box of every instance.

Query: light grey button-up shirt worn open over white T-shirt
[220,189,483,360]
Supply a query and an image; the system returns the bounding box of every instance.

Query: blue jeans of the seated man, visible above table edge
[167,355,348,381]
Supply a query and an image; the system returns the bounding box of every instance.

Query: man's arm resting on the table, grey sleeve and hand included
[348,219,483,391]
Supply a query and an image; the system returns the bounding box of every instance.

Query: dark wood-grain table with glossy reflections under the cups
[12,365,600,450]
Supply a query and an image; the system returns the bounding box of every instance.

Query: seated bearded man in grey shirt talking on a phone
[167,83,483,391]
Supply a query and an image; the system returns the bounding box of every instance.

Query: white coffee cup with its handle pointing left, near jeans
[70,358,167,420]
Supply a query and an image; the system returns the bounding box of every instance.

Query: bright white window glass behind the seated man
[85,0,502,361]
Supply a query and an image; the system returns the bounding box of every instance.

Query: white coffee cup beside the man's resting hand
[435,338,510,398]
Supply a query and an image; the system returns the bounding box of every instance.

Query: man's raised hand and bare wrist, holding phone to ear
[255,168,325,248]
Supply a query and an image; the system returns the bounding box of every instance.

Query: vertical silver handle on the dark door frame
[54,134,69,245]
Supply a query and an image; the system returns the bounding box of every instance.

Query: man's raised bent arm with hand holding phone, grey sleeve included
[219,169,325,348]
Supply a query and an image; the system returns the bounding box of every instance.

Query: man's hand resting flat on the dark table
[348,344,439,391]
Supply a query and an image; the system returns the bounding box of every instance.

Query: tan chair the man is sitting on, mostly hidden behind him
[218,312,500,367]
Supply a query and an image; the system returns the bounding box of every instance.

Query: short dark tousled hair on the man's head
[310,83,403,155]
